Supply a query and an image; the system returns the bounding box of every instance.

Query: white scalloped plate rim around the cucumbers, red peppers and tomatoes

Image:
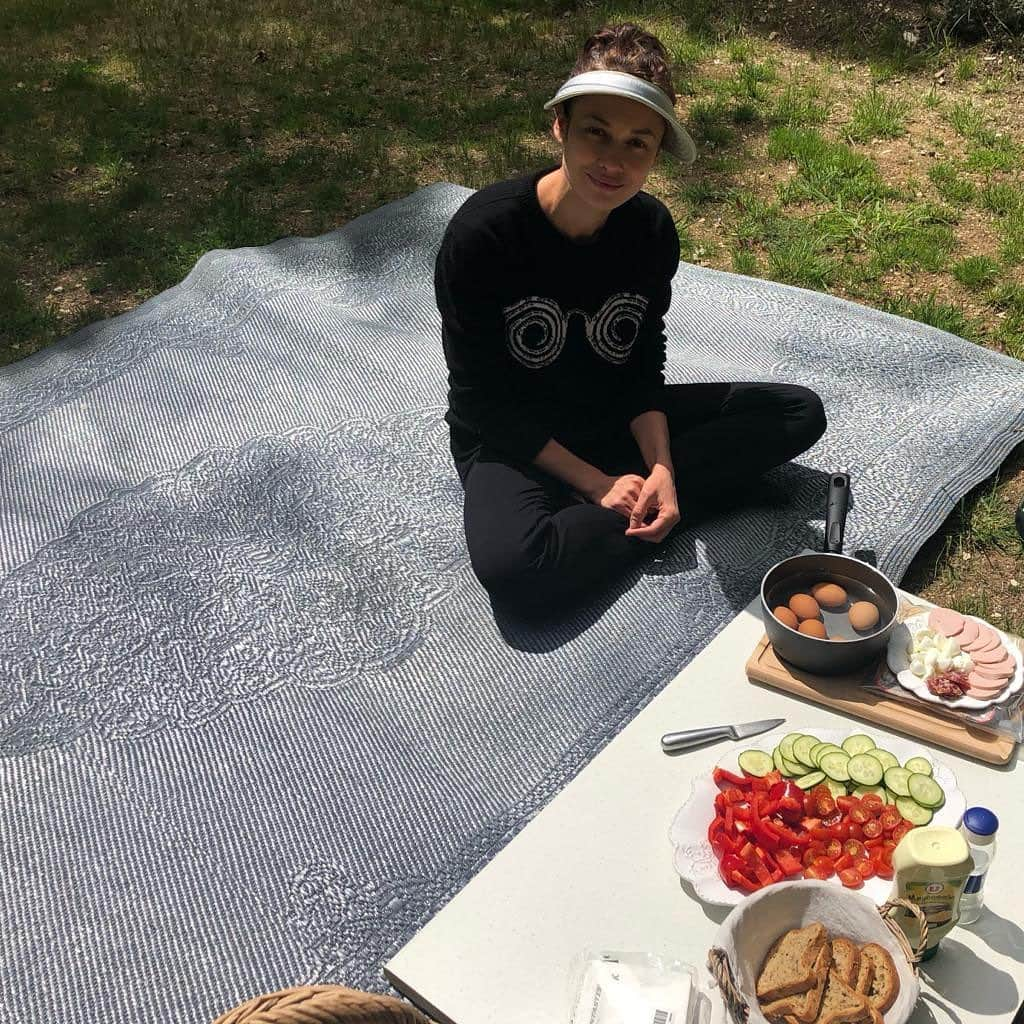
[669,728,967,906]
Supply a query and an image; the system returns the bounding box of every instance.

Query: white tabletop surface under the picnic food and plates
[385,601,1024,1024]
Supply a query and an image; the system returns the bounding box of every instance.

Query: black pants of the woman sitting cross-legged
[457,383,825,611]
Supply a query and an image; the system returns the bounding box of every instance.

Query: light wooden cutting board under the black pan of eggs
[746,605,1017,765]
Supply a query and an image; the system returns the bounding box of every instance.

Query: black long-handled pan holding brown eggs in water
[761,473,899,676]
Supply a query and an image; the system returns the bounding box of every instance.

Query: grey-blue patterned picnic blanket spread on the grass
[0,184,1024,1024]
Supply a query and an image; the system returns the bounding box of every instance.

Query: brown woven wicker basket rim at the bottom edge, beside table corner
[214,985,431,1024]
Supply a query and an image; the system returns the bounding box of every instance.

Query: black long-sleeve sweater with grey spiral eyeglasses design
[434,167,679,461]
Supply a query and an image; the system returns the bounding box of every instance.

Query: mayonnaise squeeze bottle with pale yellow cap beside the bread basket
[893,825,974,959]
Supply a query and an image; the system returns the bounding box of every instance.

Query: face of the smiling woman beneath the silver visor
[554,95,667,212]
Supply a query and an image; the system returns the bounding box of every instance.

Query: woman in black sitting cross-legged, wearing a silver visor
[434,25,825,610]
